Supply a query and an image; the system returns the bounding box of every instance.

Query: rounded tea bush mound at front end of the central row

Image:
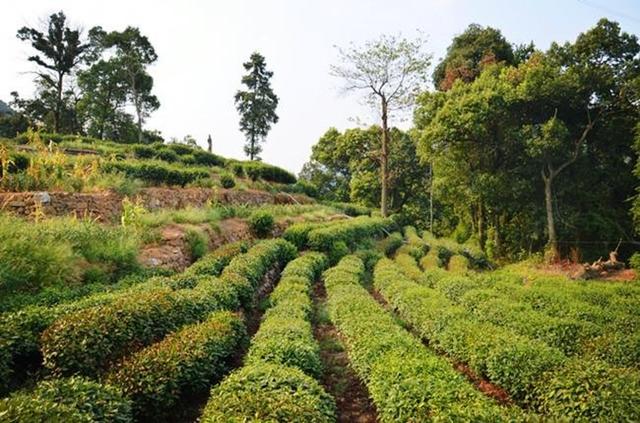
[200,363,336,423]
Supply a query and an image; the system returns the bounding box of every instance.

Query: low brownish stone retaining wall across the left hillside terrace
[0,188,313,222]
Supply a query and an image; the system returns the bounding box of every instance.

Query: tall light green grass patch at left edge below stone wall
[0,214,139,298]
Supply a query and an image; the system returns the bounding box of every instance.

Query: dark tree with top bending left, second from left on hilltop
[89,27,160,143]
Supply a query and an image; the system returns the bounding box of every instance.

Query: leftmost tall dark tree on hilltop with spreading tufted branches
[17,12,89,132]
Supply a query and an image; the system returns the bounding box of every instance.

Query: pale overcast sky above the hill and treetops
[0,0,640,173]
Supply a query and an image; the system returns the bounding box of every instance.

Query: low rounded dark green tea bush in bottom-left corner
[0,377,134,423]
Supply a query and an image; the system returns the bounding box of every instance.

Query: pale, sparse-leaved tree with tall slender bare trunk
[331,36,431,216]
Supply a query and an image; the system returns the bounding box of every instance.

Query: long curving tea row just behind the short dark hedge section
[41,239,297,375]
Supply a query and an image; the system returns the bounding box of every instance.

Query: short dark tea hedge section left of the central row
[106,311,246,419]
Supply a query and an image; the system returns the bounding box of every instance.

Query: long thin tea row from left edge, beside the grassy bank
[0,241,248,394]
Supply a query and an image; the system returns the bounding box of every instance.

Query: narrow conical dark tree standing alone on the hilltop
[235,52,278,160]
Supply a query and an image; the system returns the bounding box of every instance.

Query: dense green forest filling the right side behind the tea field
[301,19,640,260]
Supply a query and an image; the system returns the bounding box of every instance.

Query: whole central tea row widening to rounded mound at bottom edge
[200,253,336,422]
